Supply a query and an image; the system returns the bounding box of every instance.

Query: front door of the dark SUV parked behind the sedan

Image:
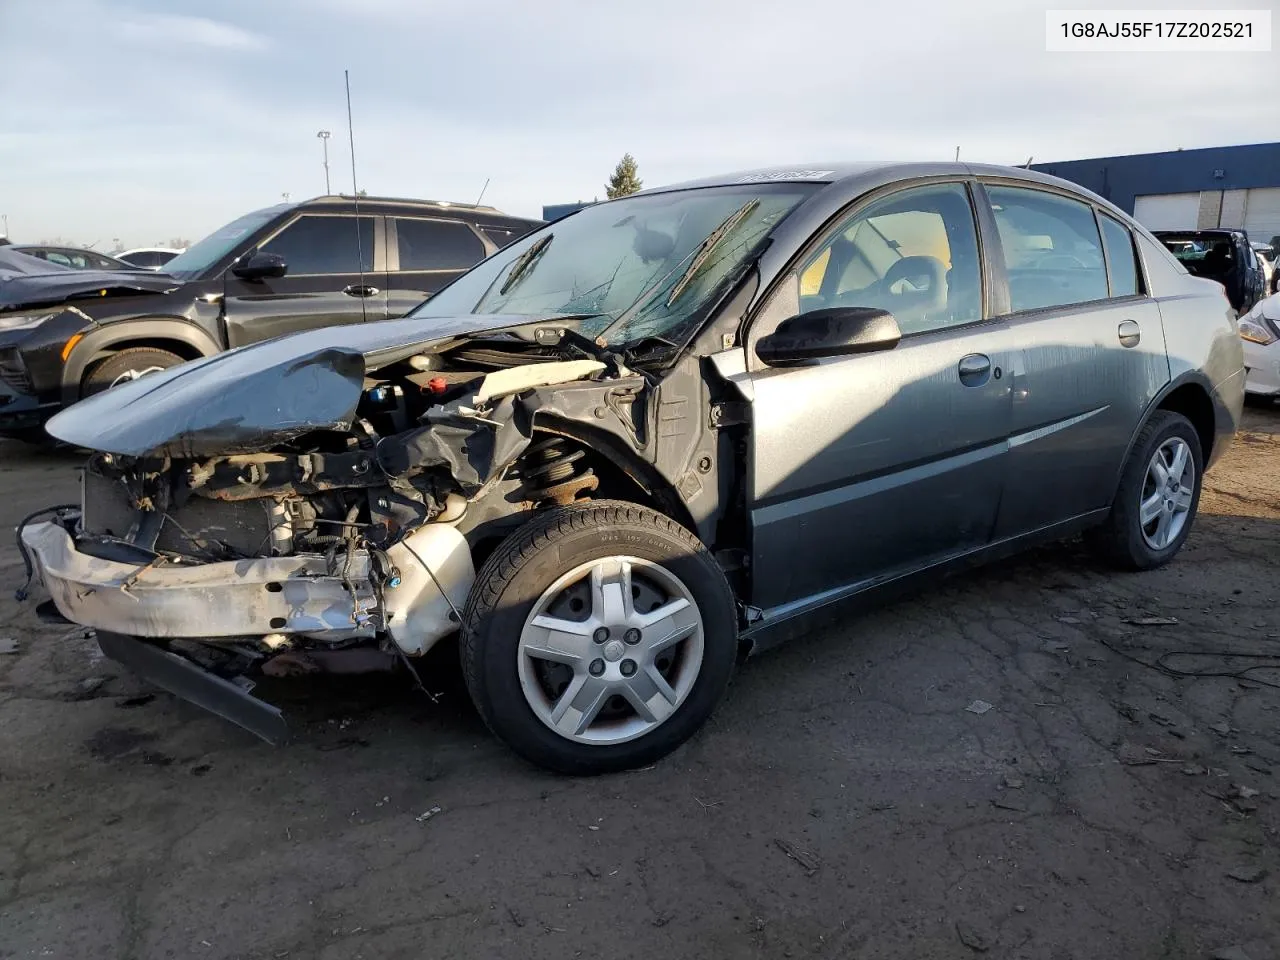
[224,214,387,347]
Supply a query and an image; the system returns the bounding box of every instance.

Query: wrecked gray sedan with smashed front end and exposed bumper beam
[19,164,1243,773]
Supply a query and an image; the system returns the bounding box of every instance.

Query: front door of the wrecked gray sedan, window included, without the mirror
[749,182,1012,609]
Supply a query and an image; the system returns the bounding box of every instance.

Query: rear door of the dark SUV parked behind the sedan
[387,216,497,316]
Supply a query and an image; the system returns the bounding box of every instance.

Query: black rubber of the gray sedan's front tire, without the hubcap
[461,500,737,774]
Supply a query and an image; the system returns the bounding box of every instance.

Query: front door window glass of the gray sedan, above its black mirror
[799,183,982,335]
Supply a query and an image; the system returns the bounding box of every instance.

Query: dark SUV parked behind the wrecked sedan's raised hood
[0,197,540,439]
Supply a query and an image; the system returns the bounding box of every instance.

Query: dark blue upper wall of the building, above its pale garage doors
[1032,143,1280,214]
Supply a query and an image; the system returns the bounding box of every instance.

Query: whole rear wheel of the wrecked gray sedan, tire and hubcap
[1088,410,1204,570]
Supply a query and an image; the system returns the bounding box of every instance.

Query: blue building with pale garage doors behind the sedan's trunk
[1032,143,1280,243]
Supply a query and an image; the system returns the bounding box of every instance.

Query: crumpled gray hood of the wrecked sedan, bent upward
[45,315,552,458]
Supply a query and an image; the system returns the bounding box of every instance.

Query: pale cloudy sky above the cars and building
[0,0,1280,250]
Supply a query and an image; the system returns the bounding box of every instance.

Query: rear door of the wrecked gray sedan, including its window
[984,182,1169,540]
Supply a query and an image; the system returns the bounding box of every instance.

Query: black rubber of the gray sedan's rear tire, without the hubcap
[1085,410,1204,570]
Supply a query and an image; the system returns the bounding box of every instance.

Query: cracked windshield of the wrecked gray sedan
[415,184,812,344]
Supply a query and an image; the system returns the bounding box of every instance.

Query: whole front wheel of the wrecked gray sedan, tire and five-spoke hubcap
[461,500,737,774]
